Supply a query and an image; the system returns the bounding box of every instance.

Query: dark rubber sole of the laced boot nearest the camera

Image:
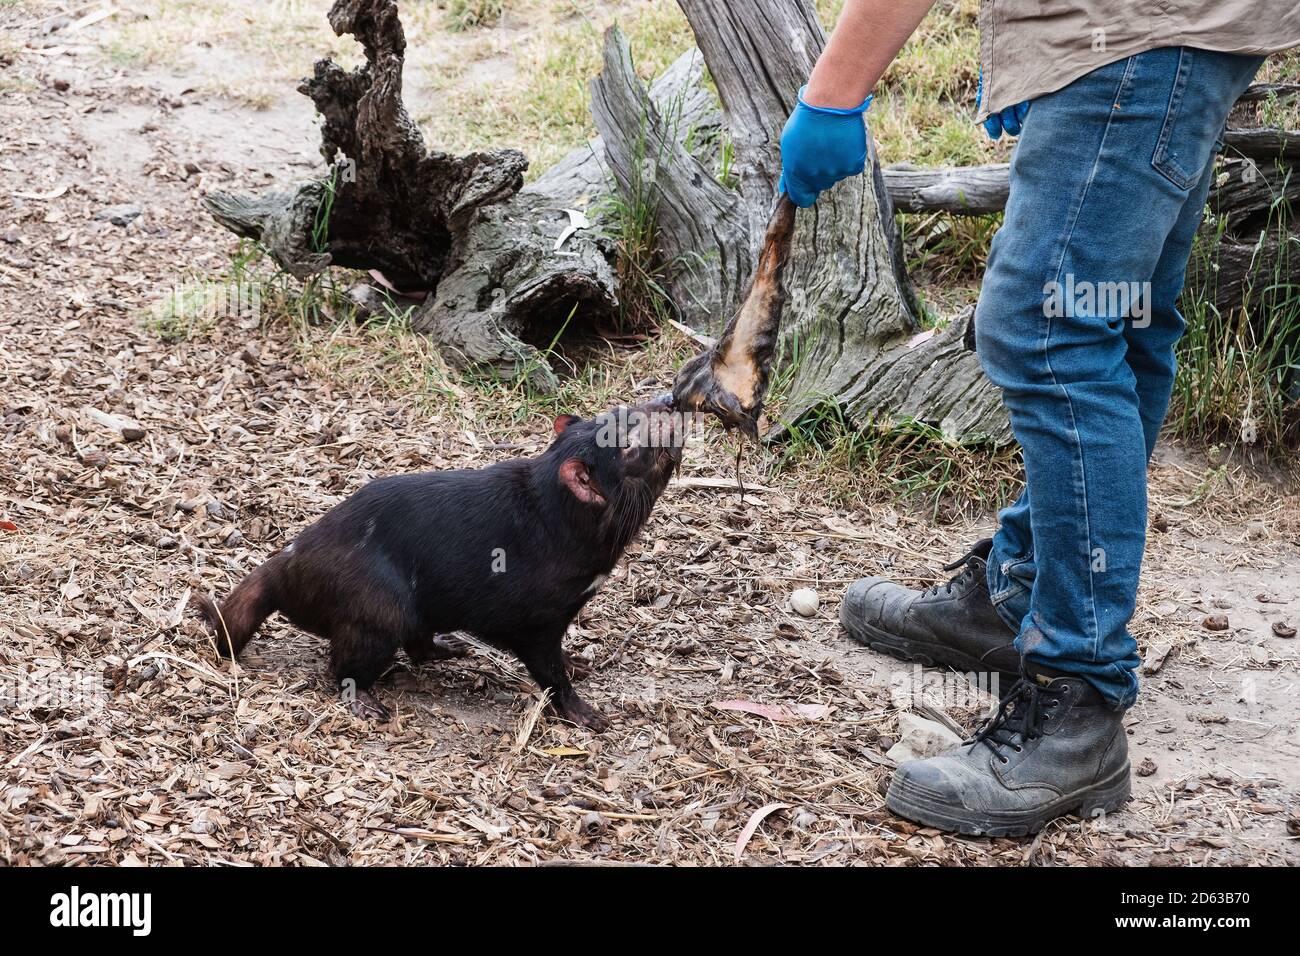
[885,763,1132,836]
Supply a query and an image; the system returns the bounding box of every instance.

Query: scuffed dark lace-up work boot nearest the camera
[885,665,1130,836]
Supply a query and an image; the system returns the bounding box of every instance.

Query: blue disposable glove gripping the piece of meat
[777,86,871,207]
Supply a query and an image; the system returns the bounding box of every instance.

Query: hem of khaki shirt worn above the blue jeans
[979,0,1300,120]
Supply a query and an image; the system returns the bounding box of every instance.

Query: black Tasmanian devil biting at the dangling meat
[196,397,684,730]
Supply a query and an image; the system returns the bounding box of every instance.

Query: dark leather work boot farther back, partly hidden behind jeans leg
[840,538,1021,682]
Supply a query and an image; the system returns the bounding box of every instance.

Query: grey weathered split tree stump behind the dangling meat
[592,0,1010,442]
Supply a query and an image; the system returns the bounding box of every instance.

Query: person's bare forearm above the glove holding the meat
[803,0,935,109]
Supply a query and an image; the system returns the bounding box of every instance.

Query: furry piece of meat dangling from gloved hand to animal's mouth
[672,193,794,440]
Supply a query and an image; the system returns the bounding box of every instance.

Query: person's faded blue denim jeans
[975,47,1262,709]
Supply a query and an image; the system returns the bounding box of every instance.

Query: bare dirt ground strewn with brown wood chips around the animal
[0,8,1300,866]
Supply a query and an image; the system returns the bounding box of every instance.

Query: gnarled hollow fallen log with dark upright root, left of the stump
[204,0,743,389]
